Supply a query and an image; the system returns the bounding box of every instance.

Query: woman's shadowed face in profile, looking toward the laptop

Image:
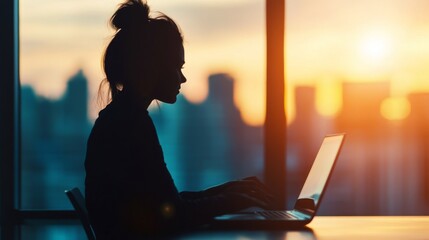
[154,44,186,103]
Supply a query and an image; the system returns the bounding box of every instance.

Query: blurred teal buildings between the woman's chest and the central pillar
[151,73,263,190]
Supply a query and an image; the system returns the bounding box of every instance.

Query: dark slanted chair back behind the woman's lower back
[65,188,95,240]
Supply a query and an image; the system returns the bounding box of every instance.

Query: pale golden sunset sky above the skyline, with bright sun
[20,0,429,124]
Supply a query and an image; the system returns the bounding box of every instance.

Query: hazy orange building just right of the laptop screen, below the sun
[336,81,390,215]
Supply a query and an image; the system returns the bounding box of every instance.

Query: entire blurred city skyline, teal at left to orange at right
[22,68,429,215]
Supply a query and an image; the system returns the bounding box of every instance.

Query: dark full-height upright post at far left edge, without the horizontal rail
[0,0,19,239]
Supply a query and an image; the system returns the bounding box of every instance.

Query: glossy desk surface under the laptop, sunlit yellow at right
[178,216,429,240]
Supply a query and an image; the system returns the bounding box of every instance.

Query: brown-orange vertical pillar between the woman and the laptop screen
[264,0,286,207]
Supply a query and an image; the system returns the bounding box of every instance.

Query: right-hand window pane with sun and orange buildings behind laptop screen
[286,0,429,215]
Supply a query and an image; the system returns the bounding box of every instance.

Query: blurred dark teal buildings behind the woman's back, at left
[21,70,91,209]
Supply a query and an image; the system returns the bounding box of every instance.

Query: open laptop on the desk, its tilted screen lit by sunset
[211,133,345,229]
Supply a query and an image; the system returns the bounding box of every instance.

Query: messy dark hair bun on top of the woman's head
[110,0,149,30]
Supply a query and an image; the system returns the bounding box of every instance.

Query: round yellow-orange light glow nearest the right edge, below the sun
[380,98,410,121]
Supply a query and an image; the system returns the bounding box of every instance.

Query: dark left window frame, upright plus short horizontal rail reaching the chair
[0,0,77,239]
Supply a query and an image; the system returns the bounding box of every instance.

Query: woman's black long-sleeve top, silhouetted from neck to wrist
[85,93,234,235]
